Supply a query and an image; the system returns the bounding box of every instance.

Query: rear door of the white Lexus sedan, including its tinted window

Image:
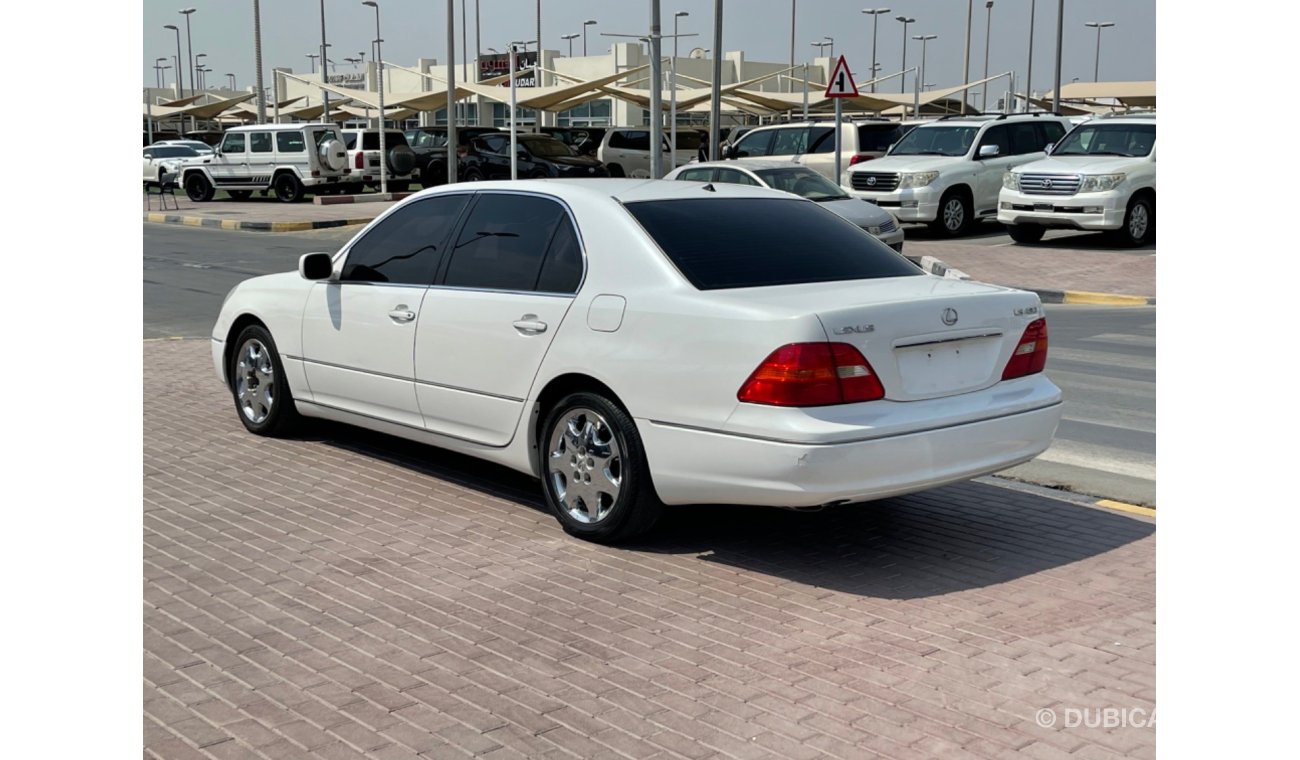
[415,192,582,446]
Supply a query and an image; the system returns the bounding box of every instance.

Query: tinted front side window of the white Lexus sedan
[343,195,469,285]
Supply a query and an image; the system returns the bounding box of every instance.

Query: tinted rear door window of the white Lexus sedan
[443,194,568,291]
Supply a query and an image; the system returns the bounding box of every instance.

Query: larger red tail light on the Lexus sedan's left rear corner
[736,343,885,407]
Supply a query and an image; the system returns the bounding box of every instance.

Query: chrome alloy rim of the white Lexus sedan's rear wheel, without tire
[547,407,623,525]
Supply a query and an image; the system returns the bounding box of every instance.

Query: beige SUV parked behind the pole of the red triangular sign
[723,120,920,184]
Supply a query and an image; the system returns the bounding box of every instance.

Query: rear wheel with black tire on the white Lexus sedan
[537,391,663,543]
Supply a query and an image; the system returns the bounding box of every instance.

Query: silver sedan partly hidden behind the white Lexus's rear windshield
[664,158,904,253]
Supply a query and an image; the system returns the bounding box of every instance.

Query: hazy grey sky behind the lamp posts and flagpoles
[140,0,1156,92]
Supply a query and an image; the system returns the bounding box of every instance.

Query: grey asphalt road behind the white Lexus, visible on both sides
[144,225,1156,505]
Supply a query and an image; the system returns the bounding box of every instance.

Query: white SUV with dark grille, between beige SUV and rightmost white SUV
[845,114,1070,235]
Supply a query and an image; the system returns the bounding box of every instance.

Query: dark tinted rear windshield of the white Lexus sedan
[627,197,920,290]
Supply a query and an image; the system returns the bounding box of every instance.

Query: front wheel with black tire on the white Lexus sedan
[226,325,302,438]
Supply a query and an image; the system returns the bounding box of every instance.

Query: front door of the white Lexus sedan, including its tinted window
[303,194,472,429]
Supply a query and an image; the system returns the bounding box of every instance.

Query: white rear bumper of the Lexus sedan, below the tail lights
[637,401,1062,507]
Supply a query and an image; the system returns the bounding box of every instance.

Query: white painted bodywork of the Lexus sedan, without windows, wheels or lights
[213,179,1061,507]
